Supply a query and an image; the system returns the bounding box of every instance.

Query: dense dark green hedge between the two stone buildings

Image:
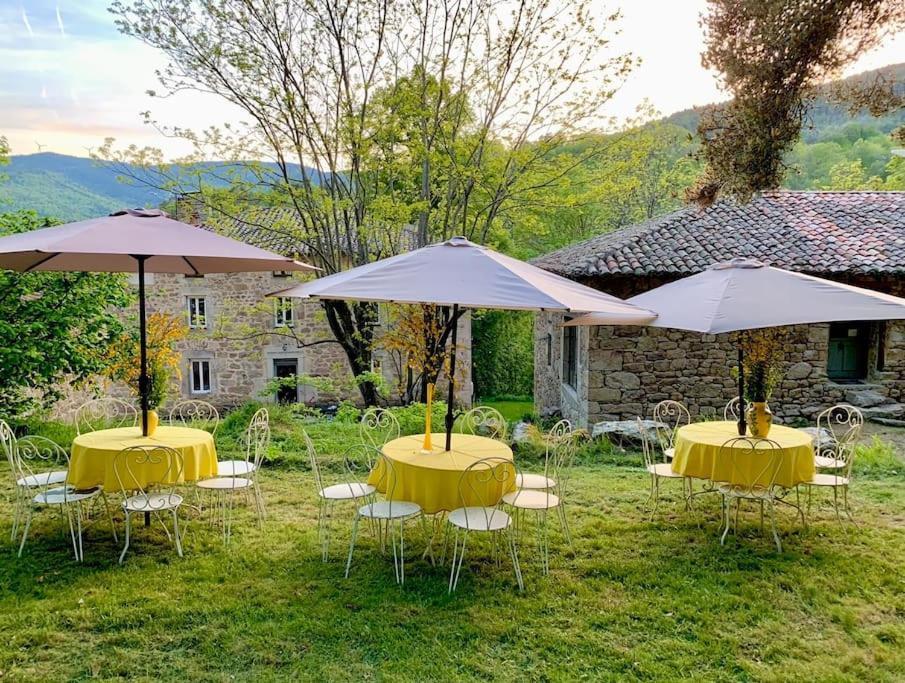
[471,311,534,397]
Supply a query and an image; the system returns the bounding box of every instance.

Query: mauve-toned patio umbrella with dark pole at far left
[0,209,316,435]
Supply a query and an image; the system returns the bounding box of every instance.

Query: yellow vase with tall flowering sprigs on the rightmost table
[740,327,782,439]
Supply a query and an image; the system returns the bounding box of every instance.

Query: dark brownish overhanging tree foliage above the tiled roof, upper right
[689,0,905,204]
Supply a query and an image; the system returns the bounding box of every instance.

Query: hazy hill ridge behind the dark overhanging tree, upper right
[664,63,905,143]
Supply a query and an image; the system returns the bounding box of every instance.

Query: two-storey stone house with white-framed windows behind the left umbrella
[74,204,472,410]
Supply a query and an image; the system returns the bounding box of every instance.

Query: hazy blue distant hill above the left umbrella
[0,152,318,221]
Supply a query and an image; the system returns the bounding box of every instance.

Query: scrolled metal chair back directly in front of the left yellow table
[113,446,185,512]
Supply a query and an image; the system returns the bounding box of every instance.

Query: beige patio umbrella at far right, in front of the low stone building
[566,258,905,435]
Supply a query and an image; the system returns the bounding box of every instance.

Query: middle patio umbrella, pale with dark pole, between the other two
[271,237,655,450]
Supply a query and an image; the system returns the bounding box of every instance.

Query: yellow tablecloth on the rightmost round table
[672,422,814,488]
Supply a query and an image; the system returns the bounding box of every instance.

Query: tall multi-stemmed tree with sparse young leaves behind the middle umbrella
[108,0,634,404]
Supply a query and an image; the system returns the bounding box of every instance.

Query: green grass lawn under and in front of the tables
[0,424,905,681]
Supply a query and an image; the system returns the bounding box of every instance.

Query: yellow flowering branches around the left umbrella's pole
[107,313,187,409]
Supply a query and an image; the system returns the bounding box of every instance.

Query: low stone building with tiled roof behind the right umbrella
[534,191,905,425]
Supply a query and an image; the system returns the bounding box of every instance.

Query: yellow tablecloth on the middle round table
[368,433,515,514]
